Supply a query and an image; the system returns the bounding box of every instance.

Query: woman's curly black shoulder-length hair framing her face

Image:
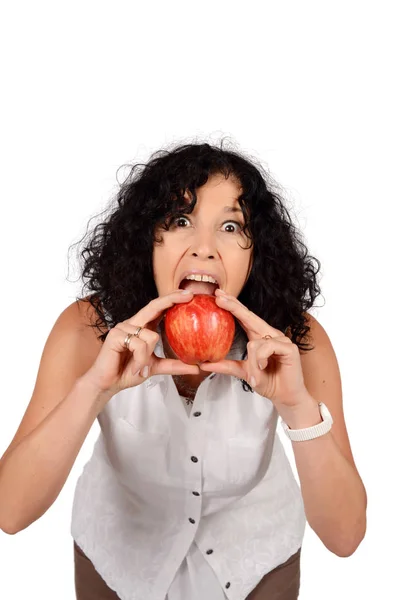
[69,141,321,386]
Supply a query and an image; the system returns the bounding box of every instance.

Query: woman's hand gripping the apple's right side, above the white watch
[199,289,309,407]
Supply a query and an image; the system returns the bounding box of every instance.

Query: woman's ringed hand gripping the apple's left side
[83,290,200,395]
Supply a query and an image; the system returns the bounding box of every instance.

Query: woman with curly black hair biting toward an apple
[0,144,366,600]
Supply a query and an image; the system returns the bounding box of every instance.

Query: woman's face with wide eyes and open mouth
[153,175,252,297]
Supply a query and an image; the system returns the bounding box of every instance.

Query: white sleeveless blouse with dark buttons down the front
[71,322,306,600]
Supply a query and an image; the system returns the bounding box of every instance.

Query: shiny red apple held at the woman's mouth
[165,294,235,365]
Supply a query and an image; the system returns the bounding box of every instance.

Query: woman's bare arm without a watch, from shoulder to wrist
[0,302,107,533]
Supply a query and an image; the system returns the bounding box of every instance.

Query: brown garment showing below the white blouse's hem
[74,541,301,600]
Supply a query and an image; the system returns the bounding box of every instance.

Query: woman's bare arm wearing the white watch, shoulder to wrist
[280,315,367,557]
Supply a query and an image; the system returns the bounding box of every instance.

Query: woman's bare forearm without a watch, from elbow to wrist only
[0,377,112,534]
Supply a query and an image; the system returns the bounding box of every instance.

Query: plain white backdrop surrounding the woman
[0,0,400,600]
